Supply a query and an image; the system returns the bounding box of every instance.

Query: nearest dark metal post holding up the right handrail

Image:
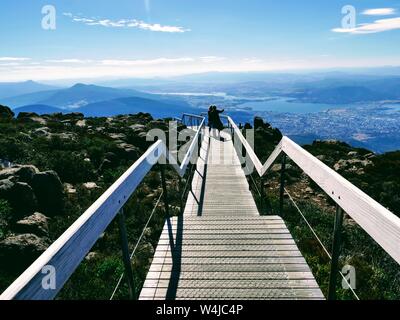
[328,206,344,300]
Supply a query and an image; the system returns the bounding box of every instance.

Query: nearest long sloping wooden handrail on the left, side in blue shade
[0,141,165,300]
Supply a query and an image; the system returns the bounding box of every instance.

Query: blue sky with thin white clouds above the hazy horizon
[0,0,400,81]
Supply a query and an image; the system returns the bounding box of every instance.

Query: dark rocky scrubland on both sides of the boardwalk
[0,106,400,299]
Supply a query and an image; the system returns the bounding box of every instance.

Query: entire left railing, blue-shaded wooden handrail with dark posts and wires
[0,114,205,300]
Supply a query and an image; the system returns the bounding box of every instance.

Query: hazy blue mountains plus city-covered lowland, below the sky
[0,76,400,151]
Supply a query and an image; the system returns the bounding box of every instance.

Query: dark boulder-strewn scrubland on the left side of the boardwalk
[0,106,184,298]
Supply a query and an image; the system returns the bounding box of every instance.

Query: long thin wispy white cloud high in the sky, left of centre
[64,12,191,33]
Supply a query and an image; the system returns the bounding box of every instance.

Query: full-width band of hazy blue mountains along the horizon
[0,72,400,118]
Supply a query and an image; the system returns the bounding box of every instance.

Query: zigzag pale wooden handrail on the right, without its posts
[227,117,400,264]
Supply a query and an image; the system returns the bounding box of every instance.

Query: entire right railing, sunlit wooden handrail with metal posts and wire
[226,117,400,299]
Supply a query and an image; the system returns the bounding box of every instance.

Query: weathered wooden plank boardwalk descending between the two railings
[140,130,324,300]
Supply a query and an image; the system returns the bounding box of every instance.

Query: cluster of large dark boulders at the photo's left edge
[0,165,64,268]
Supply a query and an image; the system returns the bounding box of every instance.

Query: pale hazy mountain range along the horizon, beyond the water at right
[105,73,400,105]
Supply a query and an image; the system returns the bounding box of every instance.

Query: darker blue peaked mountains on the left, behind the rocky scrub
[0,84,199,118]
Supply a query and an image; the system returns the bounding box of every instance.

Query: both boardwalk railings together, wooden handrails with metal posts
[0,114,400,299]
